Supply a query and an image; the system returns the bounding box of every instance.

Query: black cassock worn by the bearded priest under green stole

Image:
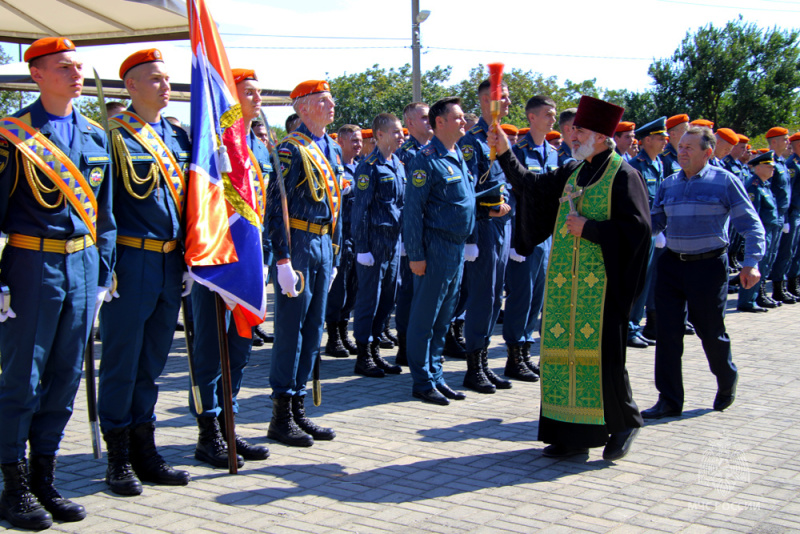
[504,150,651,447]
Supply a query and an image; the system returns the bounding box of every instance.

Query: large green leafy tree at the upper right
[649,17,800,138]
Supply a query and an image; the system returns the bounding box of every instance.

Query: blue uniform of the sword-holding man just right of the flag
[267,120,344,398]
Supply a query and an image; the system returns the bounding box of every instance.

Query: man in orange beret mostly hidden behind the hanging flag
[189,69,272,467]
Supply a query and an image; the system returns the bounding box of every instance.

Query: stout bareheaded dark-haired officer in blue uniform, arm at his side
[403,97,475,405]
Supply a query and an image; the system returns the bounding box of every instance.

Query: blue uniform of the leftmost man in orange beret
[0,100,116,464]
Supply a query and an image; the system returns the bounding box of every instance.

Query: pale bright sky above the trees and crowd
[4,0,800,129]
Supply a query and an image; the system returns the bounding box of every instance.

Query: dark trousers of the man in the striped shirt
[656,251,736,410]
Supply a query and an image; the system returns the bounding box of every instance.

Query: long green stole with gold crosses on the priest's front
[540,152,622,425]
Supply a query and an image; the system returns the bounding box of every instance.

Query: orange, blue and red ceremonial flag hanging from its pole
[185,0,267,337]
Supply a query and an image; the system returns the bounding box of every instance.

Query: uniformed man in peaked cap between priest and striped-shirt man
[628,117,667,348]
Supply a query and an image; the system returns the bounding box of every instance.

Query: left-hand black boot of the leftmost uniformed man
[0,460,53,530]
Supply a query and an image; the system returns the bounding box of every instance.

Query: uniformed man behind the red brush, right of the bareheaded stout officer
[458,80,511,393]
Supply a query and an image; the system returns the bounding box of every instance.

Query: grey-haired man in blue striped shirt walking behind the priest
[642,127,764,419]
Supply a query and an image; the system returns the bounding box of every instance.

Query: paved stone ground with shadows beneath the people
[0,288,800,534]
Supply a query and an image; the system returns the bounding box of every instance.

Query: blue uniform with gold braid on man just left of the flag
[98,107,191,433]
